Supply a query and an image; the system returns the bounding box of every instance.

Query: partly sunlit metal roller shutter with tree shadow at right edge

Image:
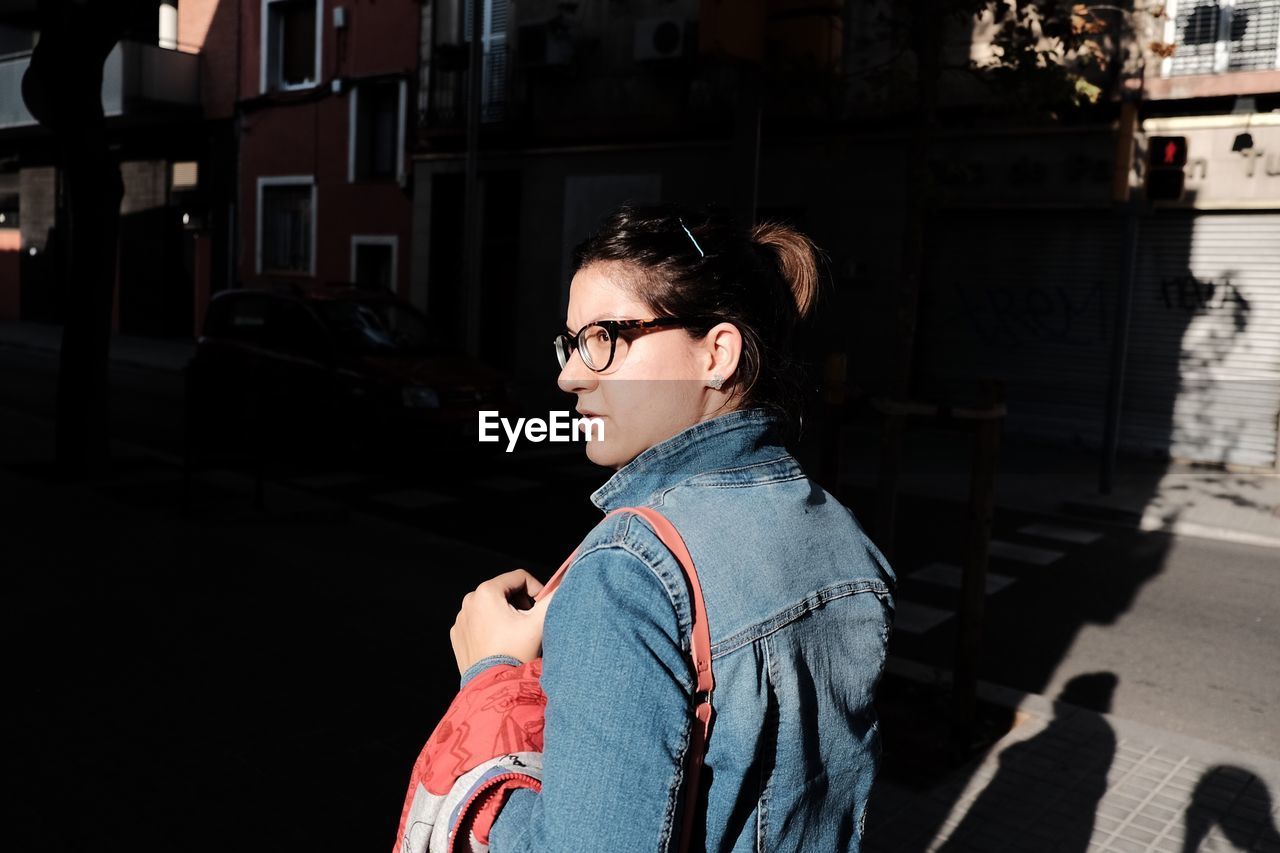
[1121,211,1280,469]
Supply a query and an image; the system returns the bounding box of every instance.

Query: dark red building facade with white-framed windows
[236,0,421,297]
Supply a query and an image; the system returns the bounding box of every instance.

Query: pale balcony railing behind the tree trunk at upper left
[0,41,200,129]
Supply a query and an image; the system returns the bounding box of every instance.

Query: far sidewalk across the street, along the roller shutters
[842,424,1280,548]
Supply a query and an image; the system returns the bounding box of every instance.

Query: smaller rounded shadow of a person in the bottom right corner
[1183,765,1280,853]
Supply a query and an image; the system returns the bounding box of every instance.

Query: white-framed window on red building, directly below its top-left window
[257,175,316,275]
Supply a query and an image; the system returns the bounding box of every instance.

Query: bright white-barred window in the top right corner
[1164,0,1280,77]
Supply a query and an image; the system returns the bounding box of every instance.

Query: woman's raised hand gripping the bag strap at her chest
[449,569,552,675]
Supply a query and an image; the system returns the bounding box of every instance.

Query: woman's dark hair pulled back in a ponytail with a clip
[573,204,818,435]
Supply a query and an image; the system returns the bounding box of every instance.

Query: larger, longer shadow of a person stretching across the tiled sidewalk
[940,672,1119,853]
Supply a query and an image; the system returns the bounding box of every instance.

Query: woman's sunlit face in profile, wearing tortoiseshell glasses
[559,261,741,467]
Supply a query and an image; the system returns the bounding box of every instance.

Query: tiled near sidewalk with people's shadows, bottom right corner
[864,674,1280,853]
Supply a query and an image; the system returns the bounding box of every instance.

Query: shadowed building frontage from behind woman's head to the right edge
[412,0,1280,470]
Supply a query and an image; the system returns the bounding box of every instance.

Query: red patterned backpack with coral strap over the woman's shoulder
[394,507,714,853]
